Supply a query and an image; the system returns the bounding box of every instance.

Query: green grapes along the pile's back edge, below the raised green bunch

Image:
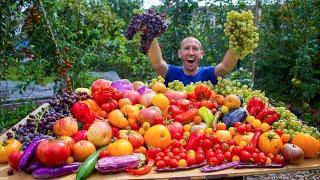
[213,77,268,102]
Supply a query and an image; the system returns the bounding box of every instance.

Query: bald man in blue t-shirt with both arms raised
[148,36,238,85]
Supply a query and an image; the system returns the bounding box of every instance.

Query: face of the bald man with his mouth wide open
[178,38,203,72]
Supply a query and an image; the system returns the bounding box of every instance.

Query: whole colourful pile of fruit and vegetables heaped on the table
[0,77,320,179]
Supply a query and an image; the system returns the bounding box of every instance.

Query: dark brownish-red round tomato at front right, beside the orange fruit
[282,143,304,164]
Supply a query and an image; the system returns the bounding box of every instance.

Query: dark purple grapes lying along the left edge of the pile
[6,92,89,149]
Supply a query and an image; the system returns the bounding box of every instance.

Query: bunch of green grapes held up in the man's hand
[224,10,259,59]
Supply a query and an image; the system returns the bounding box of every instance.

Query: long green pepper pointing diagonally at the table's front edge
[76,147,105,180]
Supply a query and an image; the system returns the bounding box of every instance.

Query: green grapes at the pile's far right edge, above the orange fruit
[272,107,320,139]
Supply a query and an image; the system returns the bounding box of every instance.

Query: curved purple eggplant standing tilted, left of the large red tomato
[19,137,47,171]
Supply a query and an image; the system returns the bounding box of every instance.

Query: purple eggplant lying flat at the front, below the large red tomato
[32,162,81,179]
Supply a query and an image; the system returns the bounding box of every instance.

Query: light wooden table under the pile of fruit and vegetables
[0,103,320,180]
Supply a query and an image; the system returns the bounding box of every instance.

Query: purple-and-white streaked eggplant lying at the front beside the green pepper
[95,153,146,173]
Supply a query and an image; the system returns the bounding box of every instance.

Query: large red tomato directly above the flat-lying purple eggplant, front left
[36,140,70,166]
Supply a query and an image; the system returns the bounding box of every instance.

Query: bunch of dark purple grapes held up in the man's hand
[125,9,167,54]
